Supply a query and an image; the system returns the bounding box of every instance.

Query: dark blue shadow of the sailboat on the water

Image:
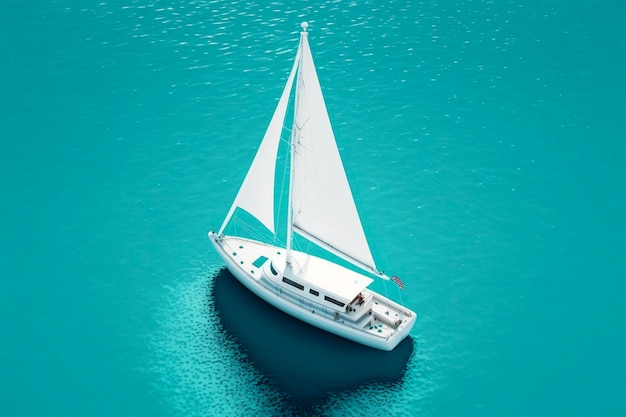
[211,268,414,402]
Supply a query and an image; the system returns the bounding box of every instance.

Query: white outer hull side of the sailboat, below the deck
[209,232,416,351]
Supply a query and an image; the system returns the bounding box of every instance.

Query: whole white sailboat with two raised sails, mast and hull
[209,22,417,351]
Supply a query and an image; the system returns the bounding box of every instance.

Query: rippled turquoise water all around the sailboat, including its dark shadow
[0,0,626,416]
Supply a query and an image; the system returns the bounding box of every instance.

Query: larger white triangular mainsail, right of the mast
[291,31,376,271]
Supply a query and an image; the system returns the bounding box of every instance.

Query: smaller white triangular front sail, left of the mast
[219,48,300,234]
